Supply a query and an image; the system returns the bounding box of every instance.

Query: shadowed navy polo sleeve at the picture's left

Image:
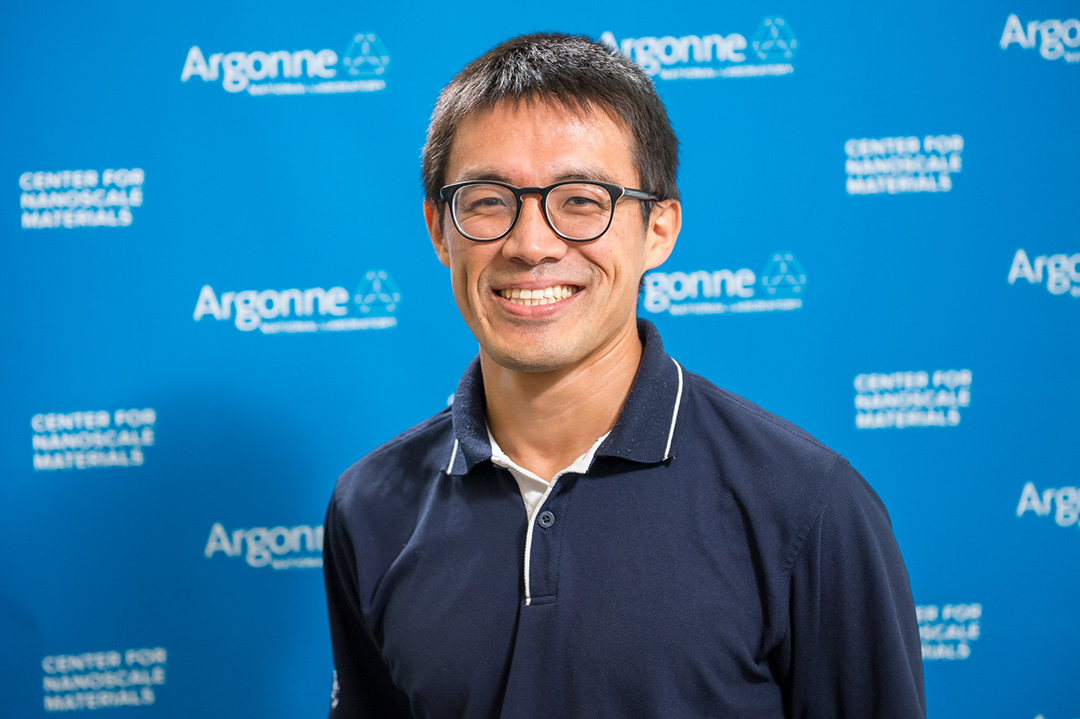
[323,490,411,719]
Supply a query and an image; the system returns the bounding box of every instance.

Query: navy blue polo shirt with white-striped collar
[324,321,926,719]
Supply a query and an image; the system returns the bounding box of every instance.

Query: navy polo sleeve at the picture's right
[780,459,927,719]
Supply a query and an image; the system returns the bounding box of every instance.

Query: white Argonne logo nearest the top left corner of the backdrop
[180,32,390,95]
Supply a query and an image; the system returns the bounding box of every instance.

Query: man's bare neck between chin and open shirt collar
[480,327,643,481]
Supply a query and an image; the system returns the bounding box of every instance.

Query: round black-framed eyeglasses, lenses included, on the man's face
[440,180,660,242]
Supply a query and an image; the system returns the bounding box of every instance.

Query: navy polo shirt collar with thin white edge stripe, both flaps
[446,318,683,474]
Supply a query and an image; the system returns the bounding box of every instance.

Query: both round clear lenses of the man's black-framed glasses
[454,182,611,240]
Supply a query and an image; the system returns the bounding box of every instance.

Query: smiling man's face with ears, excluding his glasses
[424,101,680,371]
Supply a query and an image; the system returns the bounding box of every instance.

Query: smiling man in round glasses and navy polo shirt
[324,35,926,719]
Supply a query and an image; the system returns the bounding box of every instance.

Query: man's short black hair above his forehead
[421,32,678,220]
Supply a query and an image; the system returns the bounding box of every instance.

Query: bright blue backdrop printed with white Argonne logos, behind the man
[0,0,1080,719]
